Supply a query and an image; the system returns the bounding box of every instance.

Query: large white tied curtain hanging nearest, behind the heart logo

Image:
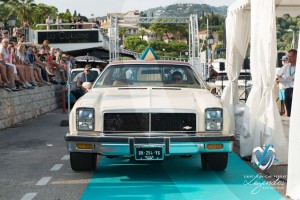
[240,0,287,164]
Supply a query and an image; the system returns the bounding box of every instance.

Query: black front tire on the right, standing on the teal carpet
[201,153,228,171]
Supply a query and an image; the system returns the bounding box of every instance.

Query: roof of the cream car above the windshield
[109,60,190,66]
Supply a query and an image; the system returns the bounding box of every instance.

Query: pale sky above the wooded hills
[34,0,236,18]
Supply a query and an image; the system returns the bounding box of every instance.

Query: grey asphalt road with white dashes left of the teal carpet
[0,110,93,200]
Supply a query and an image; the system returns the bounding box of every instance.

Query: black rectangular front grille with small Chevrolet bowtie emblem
[104,113,196,133]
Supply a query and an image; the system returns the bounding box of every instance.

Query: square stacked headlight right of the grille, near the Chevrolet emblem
[205,108,223,131]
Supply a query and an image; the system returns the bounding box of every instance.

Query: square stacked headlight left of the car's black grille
[76,108,95,131]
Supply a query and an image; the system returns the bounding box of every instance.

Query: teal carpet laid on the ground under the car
[81,153,284,200]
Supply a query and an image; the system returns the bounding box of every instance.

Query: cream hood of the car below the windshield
[75,88,221,112]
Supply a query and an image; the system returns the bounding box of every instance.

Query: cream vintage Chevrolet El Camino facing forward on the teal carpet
[65,60,234,171]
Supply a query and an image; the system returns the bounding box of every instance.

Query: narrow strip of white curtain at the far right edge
[286,34,300,199]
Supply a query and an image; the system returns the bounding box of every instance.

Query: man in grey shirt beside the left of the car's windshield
[70,65,95,100]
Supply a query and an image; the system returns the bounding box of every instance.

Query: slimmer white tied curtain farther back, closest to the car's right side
[221,9,250,133]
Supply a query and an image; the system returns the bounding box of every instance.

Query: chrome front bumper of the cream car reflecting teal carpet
[65,133,235,156]
